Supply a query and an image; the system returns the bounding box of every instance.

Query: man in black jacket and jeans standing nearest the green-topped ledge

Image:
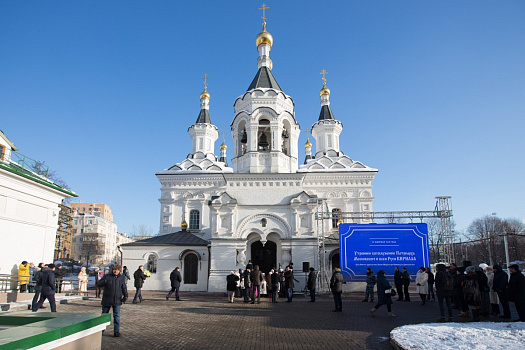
[97,264,128,337]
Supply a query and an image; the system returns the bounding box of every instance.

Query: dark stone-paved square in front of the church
[52,290,514,350]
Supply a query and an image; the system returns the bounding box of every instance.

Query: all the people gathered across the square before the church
[11,261,525,337]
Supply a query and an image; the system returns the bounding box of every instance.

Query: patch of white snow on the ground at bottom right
[390,322,525,350]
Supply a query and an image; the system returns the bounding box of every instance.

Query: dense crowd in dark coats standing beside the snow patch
[360,263,525,322]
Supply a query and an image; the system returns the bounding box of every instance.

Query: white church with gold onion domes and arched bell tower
[122,15,377,292]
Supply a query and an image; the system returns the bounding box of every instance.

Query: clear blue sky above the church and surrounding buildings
[0,0,525,232]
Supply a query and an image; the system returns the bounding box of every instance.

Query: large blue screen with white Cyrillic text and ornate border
[339,224,430,281]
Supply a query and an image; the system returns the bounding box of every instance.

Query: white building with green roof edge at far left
[0,132,76,275]
